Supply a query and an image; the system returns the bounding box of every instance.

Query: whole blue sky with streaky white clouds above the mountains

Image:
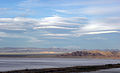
[0,0,120,49]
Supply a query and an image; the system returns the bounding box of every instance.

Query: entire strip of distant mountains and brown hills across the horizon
[0,47,120,59]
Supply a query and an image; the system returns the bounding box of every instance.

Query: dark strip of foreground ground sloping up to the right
[0,64,120,73]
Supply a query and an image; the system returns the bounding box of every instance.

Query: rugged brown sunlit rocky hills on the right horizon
[59,50,120,58]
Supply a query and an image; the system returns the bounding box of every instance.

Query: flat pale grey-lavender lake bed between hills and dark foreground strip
[0,58,120,71]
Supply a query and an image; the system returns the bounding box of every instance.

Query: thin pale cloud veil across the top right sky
[52,0,120,17]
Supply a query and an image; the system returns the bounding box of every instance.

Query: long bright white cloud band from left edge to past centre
[0,16,87,31]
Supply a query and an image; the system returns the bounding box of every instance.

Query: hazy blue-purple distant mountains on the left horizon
[0,47,78,53]
